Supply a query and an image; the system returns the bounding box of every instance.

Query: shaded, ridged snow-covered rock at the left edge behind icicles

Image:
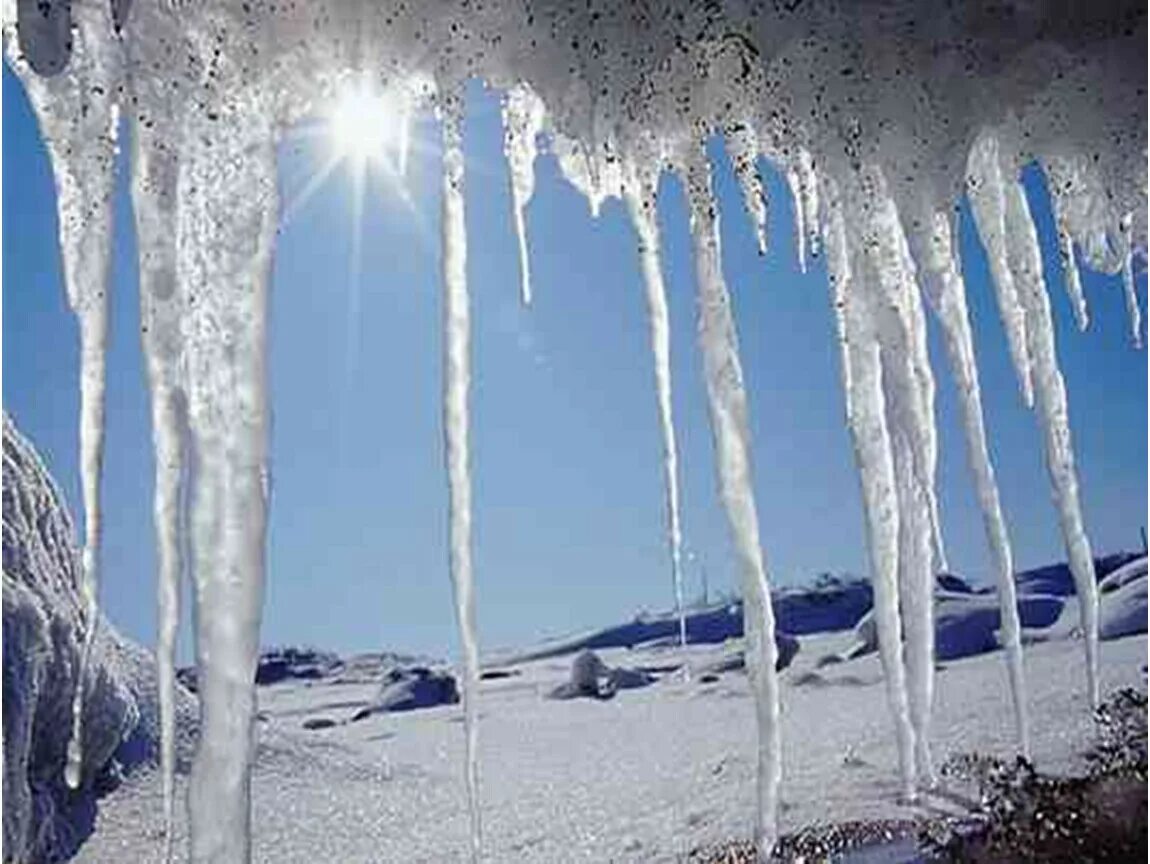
[3,414,194,861]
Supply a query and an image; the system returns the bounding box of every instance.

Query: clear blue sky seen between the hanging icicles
[3,68,1147,656]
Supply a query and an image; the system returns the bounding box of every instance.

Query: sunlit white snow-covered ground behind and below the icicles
[77,625,1147,864]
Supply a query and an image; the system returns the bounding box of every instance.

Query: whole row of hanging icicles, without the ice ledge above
[25,37,1140,861]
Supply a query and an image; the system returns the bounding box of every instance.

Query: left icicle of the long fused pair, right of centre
[826,182,917,800]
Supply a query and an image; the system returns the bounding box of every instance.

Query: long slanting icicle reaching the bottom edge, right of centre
[687,145,782,861]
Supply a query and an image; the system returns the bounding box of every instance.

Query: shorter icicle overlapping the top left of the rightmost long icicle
[967,133,1034,407]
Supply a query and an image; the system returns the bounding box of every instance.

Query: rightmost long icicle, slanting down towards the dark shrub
[1003,181,1098,706]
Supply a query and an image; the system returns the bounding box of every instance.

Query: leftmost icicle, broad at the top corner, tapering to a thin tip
[5,2,122,788]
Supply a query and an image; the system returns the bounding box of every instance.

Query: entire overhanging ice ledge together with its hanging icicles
[3,0,1147,861]
